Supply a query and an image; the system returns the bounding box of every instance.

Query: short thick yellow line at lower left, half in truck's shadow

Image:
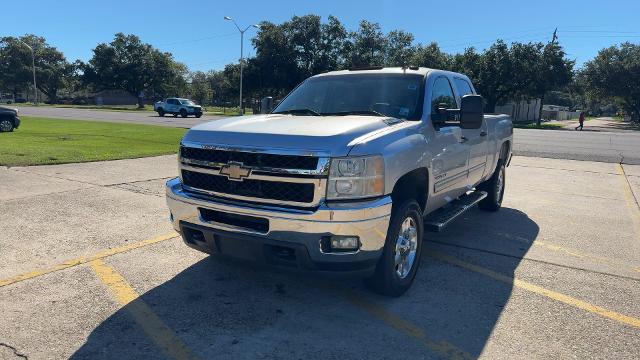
[89,259,197,360]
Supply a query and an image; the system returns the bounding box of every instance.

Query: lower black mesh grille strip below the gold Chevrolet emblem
[182,170,315,203]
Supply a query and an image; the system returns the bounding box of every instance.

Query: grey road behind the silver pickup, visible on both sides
[15,107,640,164]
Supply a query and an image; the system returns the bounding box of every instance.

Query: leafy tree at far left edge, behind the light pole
[0,35,73,103]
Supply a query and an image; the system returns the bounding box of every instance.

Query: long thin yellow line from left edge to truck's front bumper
[0,232,178,287]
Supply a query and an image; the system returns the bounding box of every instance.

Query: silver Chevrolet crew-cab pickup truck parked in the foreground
[166,67,513,296]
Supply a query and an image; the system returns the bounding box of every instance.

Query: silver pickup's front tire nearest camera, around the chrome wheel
[365,199,424,296]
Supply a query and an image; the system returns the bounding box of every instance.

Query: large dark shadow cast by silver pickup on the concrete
[71,208,538,359]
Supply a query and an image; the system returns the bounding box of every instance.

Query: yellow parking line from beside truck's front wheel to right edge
[428,251,640,328]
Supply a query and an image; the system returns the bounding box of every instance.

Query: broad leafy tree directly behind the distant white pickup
[83,33,186,107]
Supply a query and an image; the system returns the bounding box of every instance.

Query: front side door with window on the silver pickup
[429,75,469,201]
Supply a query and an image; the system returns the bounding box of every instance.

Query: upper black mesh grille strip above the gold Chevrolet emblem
[180,146,318,170]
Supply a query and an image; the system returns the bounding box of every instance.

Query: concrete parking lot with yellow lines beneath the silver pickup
[0,156,640,359]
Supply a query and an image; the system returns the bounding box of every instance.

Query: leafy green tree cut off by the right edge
[581,42,640,121]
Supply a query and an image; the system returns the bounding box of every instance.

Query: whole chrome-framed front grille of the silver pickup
[180,143,329,207]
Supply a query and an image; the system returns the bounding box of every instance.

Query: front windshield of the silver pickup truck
[273,74,424,120]
